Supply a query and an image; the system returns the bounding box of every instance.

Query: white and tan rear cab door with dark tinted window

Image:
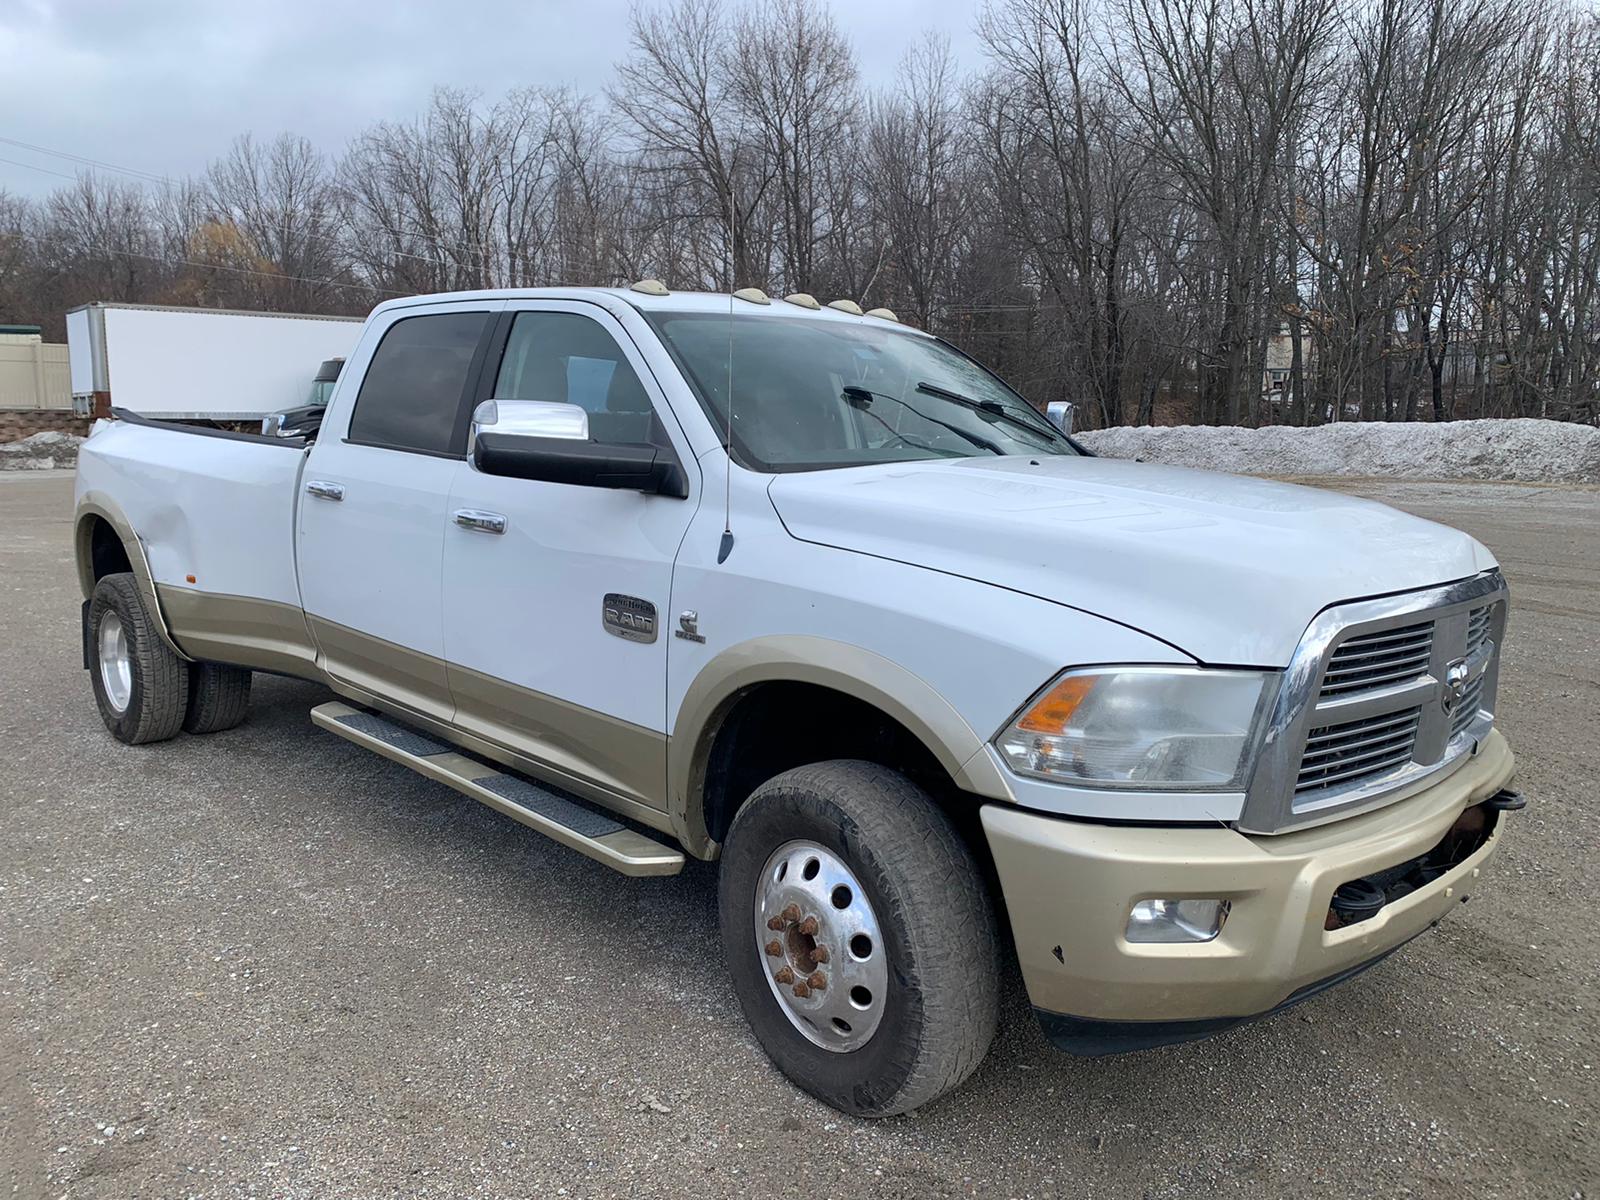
[299,301,504,720]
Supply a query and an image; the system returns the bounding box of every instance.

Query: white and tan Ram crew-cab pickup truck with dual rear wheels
[77,280,1522,1115]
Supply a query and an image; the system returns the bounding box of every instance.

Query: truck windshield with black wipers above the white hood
[646,312,1077,470]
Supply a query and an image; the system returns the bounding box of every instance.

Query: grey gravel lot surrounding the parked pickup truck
[0,472,1600,1198]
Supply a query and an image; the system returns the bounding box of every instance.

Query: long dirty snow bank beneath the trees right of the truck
[1077,419,1600,483]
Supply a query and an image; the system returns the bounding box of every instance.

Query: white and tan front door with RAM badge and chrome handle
[443,301,699,808]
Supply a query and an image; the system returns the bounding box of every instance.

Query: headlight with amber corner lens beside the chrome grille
[995,667,1277,792]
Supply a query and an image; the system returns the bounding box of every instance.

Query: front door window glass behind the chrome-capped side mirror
[494,312,666,445]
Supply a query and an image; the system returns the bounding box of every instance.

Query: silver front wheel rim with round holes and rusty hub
[754,842,890,1053]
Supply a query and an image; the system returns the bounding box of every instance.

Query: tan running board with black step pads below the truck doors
[310,701,683,875]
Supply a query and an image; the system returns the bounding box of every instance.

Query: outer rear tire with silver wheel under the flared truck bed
[88,571,189,746]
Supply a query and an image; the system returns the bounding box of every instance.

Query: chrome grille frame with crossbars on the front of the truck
[1238,570,1509,834]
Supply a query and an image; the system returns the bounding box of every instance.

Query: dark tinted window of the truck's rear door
[350,312,488,454]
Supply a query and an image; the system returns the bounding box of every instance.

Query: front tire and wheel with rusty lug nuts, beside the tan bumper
[718,760,1000,1117]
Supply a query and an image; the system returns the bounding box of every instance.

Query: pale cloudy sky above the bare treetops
[0,0,978,195]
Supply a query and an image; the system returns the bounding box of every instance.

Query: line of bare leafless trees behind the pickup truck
[0,0,1600,424]
